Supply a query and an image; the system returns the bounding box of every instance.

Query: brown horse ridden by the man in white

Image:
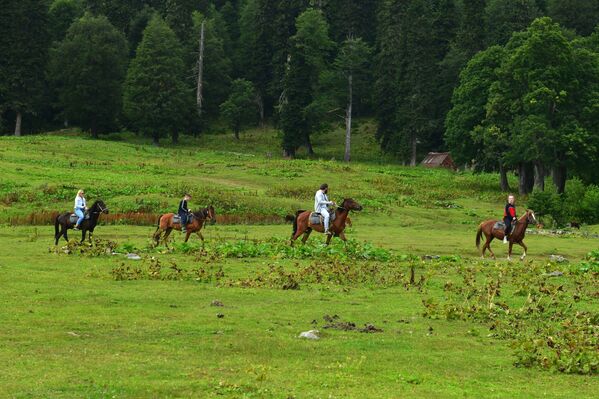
[291,198,363,246]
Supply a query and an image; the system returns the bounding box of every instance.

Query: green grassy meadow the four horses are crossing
[0,130,599,398]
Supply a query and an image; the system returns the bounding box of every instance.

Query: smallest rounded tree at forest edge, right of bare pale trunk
[220,79,258,140]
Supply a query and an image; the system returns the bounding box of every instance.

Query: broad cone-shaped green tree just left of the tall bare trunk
[124,16,192,145]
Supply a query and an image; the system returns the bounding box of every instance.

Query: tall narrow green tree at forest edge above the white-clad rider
[280,9,333,157]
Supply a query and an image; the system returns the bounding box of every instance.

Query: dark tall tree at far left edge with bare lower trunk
[0,0,50,136]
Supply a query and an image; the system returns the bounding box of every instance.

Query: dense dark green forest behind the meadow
[0,0,599,193]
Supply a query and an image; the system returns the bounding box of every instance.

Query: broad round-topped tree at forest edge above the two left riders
[51,14,127,137]
